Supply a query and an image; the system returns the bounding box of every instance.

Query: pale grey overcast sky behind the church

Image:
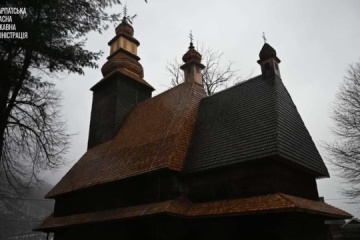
[45,0,360,217]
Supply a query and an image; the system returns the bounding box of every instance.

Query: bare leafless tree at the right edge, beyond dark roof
[327,62,360,198]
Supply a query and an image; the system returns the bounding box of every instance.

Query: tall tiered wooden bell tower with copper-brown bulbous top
[88,17,154,149]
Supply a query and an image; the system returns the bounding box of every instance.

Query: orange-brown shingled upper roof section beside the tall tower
[46,83,206,198]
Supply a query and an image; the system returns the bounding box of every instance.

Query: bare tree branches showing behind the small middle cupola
[166,45,242,95]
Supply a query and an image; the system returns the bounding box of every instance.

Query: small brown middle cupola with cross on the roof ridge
[180,31,205,85]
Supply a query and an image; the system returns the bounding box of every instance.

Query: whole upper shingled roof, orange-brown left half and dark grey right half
[47,76,328,197]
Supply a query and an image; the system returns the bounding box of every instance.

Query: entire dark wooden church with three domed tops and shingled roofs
[35,16,351,240]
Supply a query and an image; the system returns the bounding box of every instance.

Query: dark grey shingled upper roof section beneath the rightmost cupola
[184,76,329,177]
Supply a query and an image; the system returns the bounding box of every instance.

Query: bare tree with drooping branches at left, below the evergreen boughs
[0,73,69,197]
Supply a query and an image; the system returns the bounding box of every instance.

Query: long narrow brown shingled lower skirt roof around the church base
[36,193,351,231]
